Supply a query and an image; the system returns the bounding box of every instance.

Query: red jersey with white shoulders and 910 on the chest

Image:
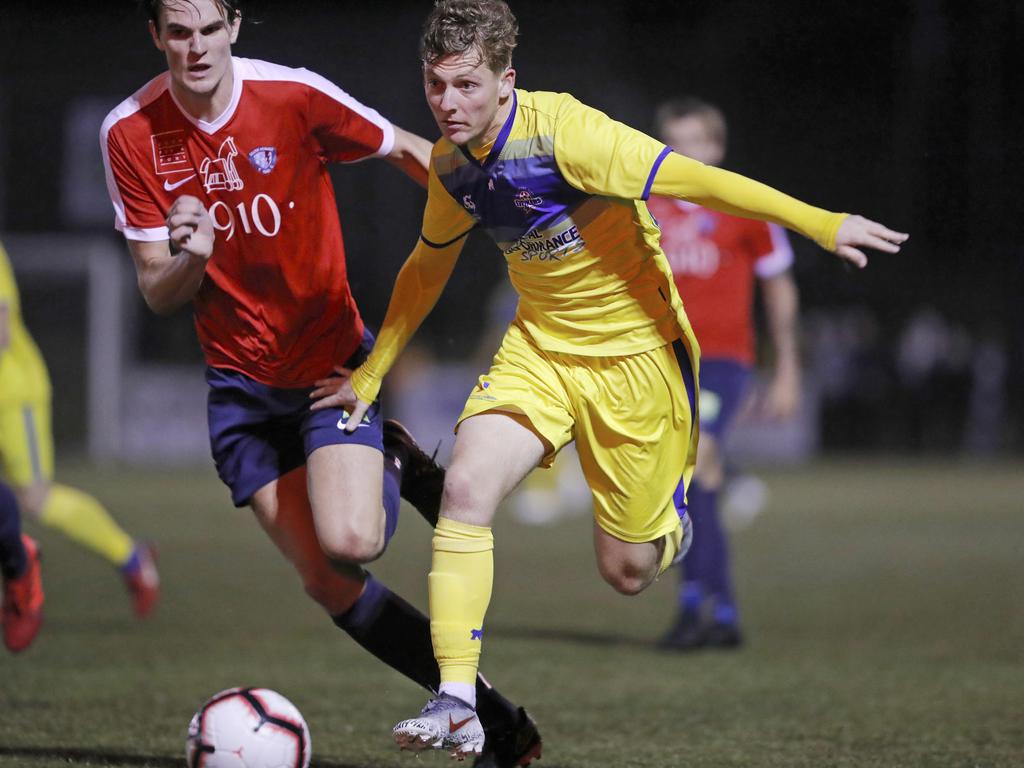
[100,58,394,387]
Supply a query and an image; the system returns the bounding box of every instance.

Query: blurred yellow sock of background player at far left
[39,483,135,566]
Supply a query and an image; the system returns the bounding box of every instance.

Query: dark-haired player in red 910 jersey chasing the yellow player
[100,0,540,766]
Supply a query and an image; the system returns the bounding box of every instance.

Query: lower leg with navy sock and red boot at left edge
[0,482,43,653]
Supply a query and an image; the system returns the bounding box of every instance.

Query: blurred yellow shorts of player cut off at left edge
[0,400,53,487]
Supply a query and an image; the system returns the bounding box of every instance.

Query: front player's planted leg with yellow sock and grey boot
[394,413,547,758]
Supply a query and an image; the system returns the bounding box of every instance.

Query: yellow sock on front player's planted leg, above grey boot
[427,517,495,685]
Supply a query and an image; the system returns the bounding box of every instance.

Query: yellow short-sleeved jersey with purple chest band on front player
[422,90,692,356]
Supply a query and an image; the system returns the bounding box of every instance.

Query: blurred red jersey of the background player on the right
[647,197,793,366]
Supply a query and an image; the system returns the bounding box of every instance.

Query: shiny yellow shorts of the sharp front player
[456,324,697,543]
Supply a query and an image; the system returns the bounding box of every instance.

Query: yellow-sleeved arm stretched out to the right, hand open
[651,153,910,266]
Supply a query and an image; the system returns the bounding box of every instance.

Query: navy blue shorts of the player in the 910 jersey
[206,331,383,507]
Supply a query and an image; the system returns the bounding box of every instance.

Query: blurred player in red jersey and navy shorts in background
[647,98,800,650]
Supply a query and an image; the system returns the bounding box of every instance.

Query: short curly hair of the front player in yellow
[420,0,519,72]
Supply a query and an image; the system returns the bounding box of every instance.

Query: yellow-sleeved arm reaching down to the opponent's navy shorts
[309,237,466,432]
